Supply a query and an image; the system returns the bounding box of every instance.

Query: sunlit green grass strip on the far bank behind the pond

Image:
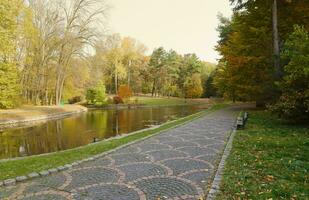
[130,97,206,106]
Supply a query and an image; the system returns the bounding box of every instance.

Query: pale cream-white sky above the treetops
[108,0,232,62]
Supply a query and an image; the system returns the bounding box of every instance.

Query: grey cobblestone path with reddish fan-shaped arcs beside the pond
[0,106,240,200]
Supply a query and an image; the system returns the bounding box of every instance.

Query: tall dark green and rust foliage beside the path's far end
[214,0,309,108]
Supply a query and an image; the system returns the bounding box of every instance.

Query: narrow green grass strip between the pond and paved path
[0,104,227,180]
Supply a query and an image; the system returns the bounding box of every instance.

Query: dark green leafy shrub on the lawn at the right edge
[270,26,309,122]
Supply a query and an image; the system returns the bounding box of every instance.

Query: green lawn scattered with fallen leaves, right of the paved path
[217,111,309,199]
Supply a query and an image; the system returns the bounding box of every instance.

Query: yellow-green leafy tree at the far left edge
[0,0,22,108]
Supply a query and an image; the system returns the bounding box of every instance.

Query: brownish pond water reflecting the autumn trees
[0,106,205,159]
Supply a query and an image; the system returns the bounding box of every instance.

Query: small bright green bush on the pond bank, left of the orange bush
[86,81,106,105]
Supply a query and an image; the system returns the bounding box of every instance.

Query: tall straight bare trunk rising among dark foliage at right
[272,0,281,79]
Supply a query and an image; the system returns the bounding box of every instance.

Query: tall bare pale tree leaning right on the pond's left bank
[55,0,106,104]
